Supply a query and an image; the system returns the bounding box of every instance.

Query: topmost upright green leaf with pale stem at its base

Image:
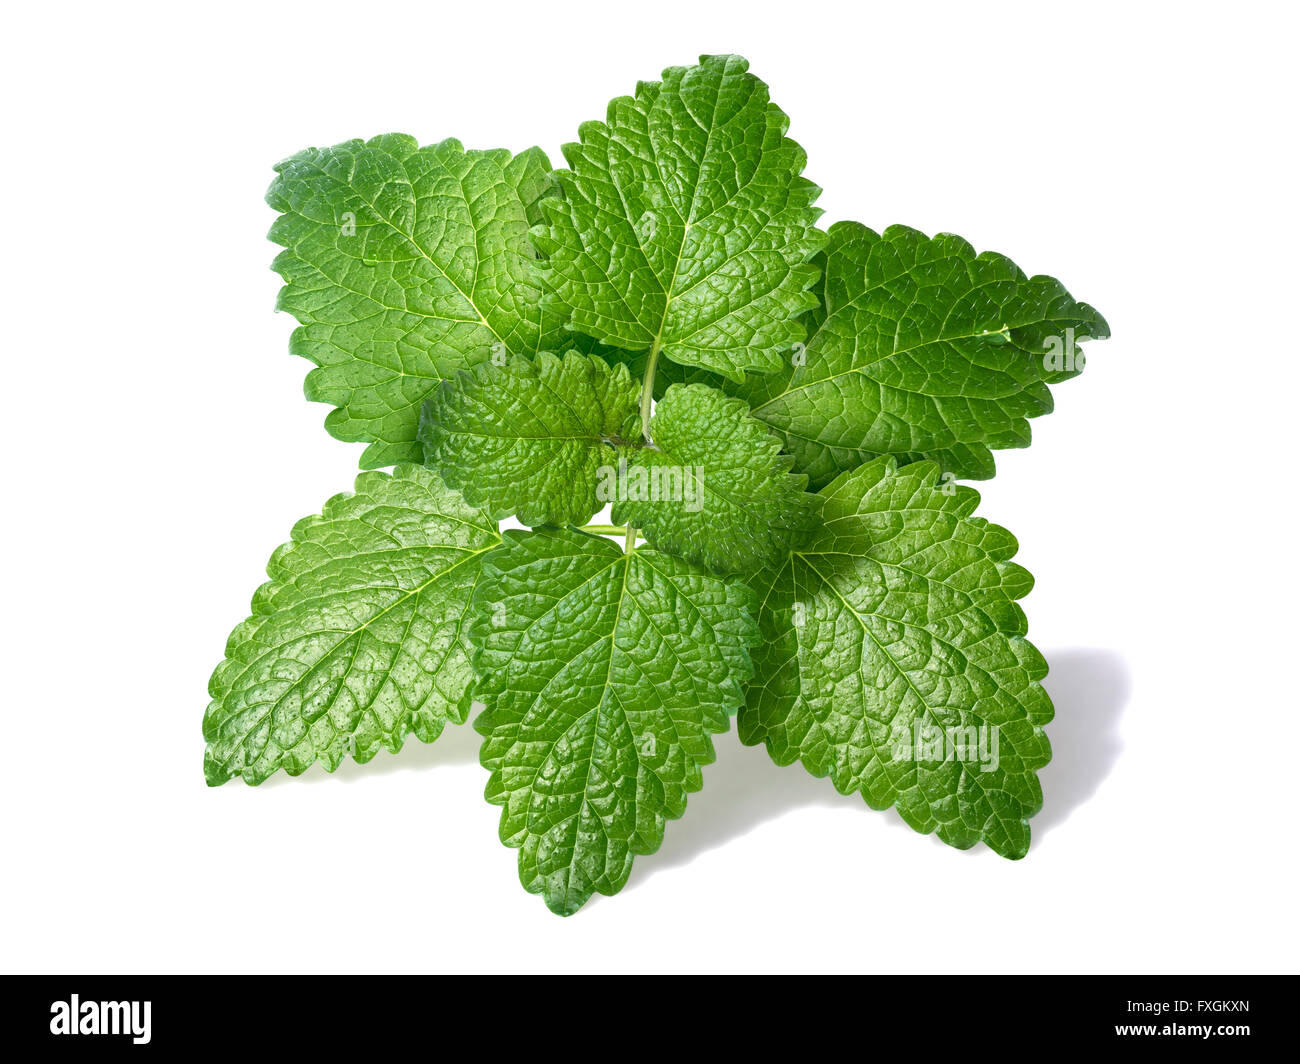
[534,56,824,380]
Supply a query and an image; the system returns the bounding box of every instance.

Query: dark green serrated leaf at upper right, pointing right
[727,222,1109,486]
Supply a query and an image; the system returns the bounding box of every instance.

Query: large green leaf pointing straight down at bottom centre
[473,529,758,916]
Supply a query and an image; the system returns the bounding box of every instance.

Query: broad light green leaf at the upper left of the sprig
[267,134,560,467]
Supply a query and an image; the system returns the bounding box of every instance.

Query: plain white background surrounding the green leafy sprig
[0,0,1300,972]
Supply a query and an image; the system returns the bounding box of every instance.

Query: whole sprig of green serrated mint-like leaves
[204,57,1105,913]
